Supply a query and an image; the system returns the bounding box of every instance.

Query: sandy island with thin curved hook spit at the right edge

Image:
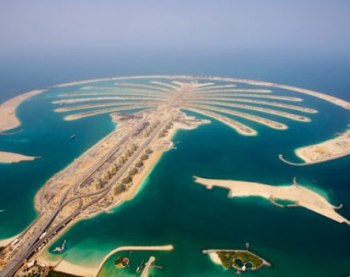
[279,130,350,166]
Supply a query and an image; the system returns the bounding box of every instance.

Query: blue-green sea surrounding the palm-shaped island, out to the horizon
[0,50,350,277]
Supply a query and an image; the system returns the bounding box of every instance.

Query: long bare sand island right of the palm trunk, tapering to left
[195,177,350,225]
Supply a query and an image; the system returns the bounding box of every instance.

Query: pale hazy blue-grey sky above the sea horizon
[0,0,350,56]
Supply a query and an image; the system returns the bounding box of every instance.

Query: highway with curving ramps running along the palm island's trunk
[0,111,172,277]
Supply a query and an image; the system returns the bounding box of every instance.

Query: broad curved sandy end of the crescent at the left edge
[0,90,46,133]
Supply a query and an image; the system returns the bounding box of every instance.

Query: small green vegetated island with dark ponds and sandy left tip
[203,249,271,272]
